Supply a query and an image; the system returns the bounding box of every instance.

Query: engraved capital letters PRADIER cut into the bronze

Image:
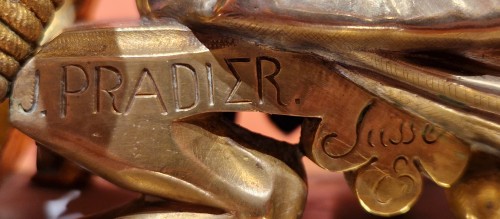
[50,56,290,118]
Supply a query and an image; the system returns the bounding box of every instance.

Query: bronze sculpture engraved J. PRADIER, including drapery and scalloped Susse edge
[0,1,500,218]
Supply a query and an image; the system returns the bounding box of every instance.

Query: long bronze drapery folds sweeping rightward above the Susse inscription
[140,0,500,154]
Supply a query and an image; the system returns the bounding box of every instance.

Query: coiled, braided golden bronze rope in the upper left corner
[0,0,64,102]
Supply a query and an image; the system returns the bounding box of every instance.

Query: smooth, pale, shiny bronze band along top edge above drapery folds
[142,0,500,29]
